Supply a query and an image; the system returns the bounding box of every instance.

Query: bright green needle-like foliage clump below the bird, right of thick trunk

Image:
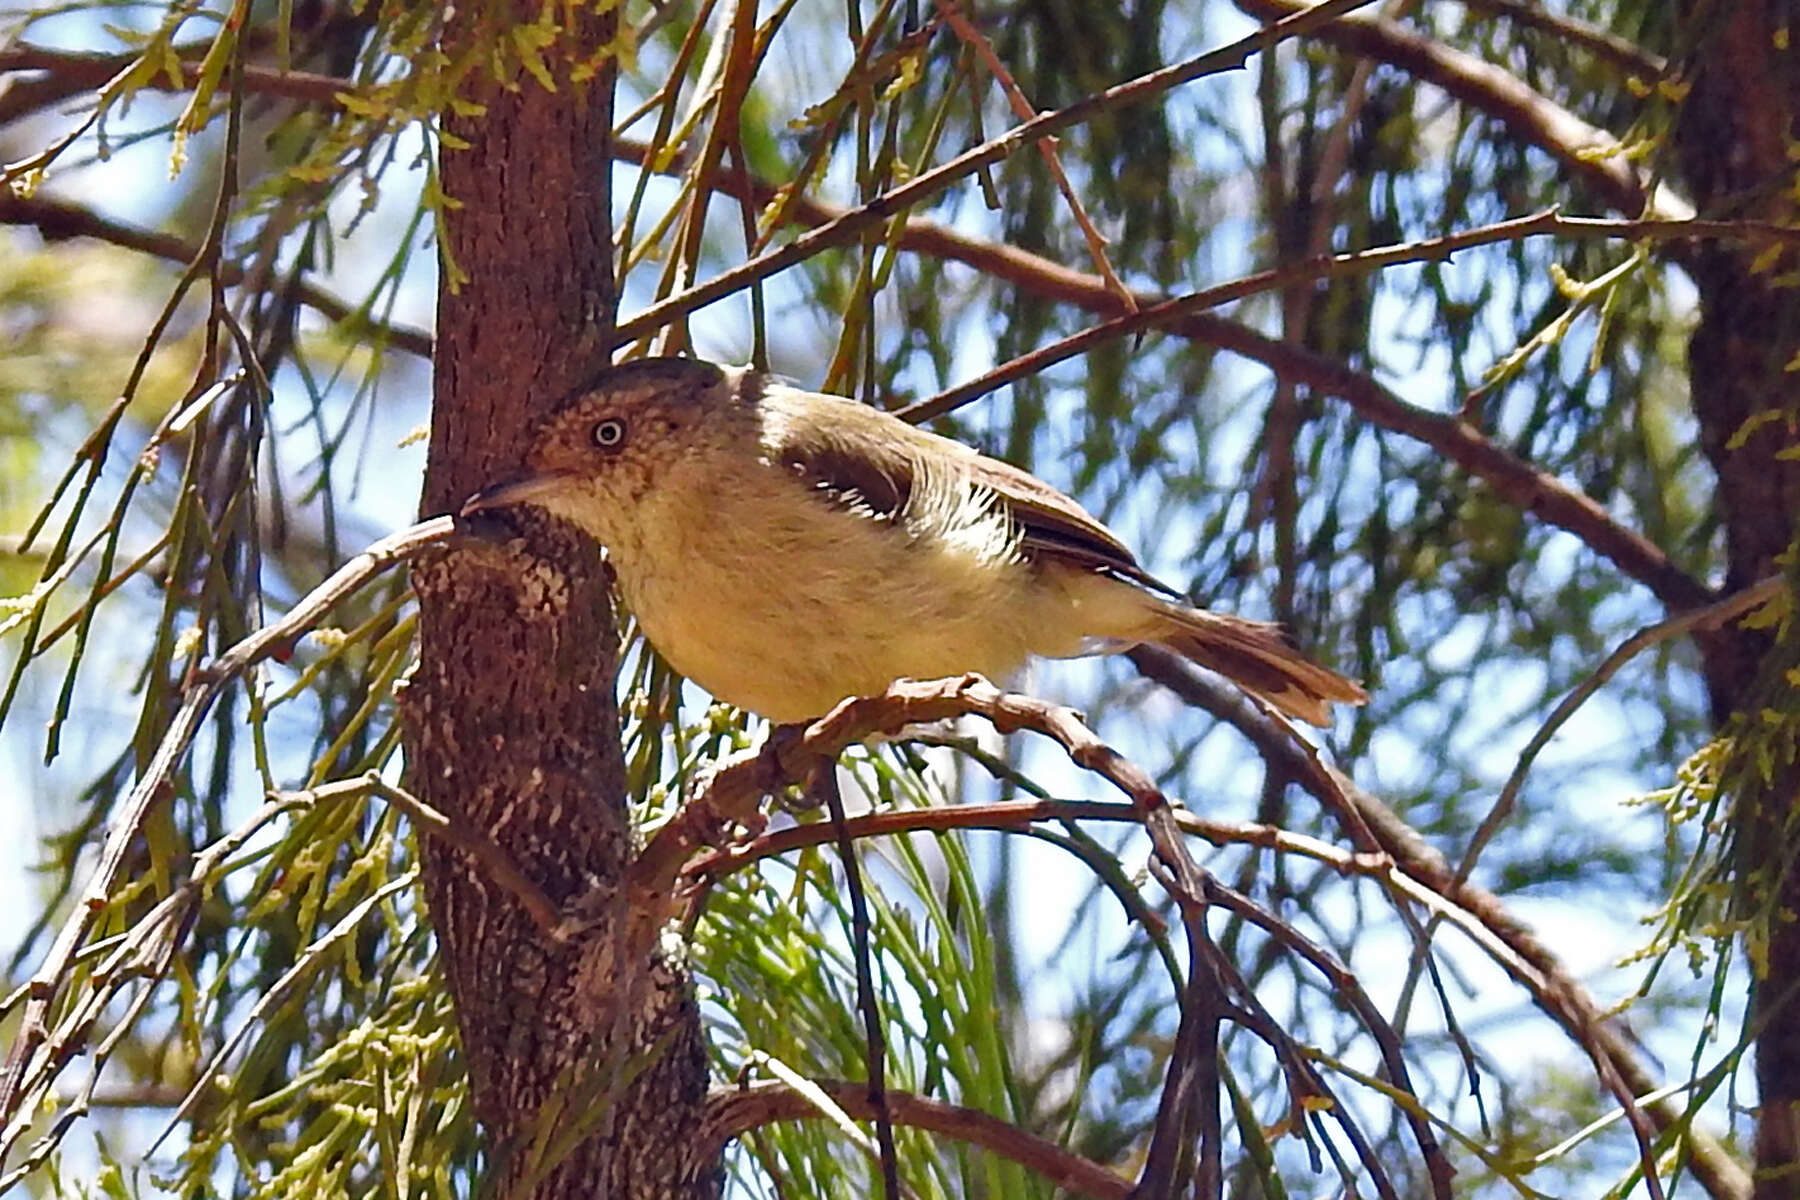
[693,754,1055,1196]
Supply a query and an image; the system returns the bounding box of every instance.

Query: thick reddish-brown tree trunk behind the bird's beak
[403,4,718,1200]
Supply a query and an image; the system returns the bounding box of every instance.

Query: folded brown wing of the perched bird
[761,385,1175,596]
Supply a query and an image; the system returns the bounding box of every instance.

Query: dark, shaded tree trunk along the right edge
[1678,0,1800,1200]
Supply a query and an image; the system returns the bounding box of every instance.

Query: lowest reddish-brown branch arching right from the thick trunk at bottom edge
[695,1079,1132,1200]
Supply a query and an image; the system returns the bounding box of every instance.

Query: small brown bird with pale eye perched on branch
[463,358,1368,725]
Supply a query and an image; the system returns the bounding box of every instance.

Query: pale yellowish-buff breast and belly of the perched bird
[612,466,1035,721]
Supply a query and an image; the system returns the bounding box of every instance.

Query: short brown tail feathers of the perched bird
[1145,601,1368,725]
